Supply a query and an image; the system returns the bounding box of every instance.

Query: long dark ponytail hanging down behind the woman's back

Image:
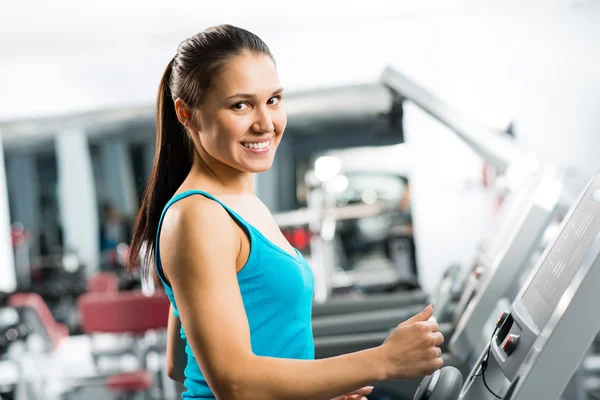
[127,58,193,277]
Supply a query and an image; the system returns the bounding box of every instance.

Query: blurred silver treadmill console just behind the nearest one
[366,167,568,398]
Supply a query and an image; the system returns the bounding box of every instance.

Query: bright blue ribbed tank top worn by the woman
[155,190,314,399]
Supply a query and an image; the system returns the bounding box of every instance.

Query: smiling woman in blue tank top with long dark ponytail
[129,25,443,400]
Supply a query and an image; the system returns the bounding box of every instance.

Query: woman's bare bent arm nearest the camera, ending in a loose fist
[160,196,443,400]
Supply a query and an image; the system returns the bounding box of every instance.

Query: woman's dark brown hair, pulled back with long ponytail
[127,25,274,276]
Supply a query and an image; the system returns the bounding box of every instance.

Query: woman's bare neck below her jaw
[190,150,254,195]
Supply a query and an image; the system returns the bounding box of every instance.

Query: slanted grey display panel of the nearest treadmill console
[521,183,600,329]
